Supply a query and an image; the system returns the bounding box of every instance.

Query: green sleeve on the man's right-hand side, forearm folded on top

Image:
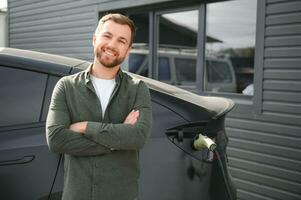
[84,82,152,150]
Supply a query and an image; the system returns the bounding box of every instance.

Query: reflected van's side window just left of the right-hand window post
[174,58,196,83]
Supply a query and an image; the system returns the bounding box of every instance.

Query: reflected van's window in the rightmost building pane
[206,60,232,83]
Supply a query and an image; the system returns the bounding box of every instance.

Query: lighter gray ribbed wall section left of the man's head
[8,0,98,60]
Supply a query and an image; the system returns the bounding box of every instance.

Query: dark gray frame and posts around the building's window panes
[96,0,266,116]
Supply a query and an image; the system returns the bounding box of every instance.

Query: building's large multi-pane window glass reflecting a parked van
[119,0,257,95]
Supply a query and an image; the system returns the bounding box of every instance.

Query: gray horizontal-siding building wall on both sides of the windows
[8,0,301,200]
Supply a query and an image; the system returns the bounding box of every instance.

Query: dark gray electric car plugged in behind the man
[0,48,236,200]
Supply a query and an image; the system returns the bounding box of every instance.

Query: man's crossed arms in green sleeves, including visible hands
[46,77,151,156]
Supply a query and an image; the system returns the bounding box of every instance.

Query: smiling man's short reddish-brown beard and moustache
[95,48,125,68]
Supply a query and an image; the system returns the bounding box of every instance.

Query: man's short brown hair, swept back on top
[94,13,136,46]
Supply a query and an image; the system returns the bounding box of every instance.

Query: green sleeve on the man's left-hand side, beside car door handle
[46,79,111,156]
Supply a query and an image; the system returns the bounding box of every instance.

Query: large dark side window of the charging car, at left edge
[0,66,47,126]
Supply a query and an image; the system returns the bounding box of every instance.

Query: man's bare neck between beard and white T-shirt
[91,60,120,79]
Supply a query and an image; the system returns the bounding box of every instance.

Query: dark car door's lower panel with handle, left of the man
[0,124,58,199]
